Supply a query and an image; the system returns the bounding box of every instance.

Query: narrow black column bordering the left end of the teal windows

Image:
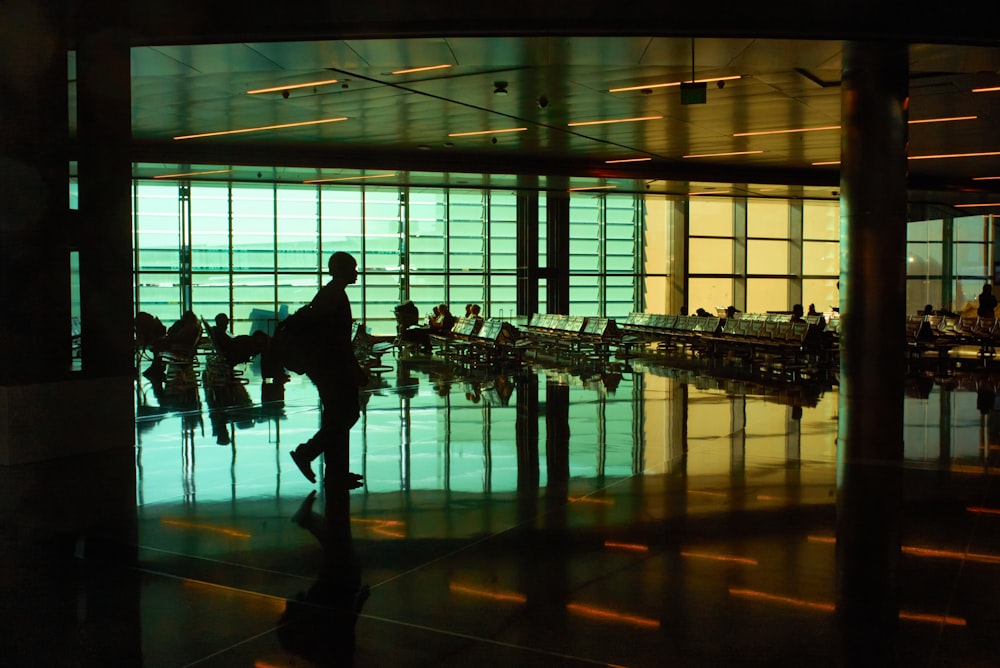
[77,0,134,377]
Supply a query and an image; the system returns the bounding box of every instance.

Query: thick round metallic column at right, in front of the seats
[837,42,908,666]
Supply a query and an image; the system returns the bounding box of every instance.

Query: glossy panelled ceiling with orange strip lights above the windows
[117,37,1000,205]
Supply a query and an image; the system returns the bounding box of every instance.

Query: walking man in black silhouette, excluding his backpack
[291,252,368,488]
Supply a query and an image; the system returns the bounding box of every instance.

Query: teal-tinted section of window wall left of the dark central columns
[133,180,528,334]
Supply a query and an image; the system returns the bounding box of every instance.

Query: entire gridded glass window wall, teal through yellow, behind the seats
[133,180,860,335]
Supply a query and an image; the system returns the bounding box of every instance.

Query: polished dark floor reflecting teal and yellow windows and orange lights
[0,356,1000,668]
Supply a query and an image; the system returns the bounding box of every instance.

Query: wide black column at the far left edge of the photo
[0,2,70,385]
